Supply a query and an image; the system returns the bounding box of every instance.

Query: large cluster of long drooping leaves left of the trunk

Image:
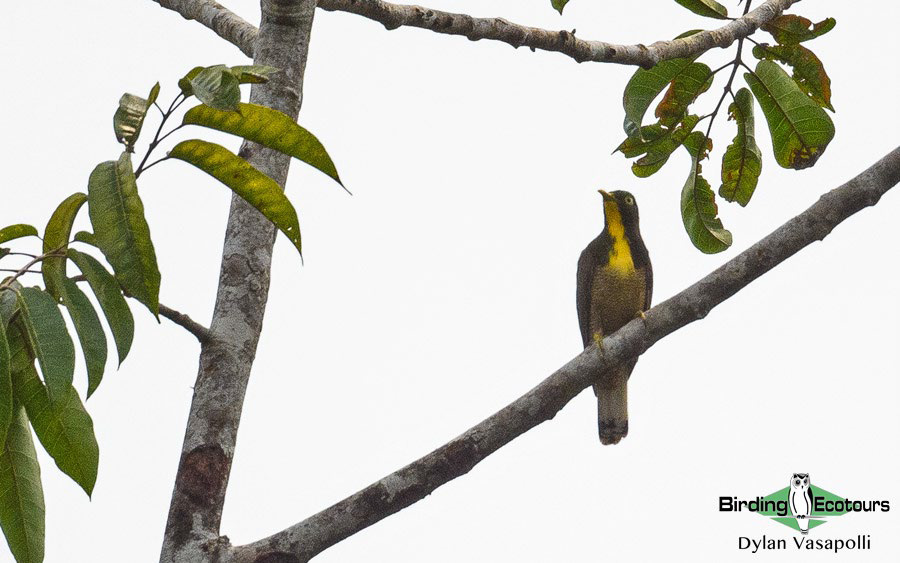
[0,65,340,563]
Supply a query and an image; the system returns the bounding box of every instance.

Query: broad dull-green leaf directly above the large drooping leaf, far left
[17,287,75,404]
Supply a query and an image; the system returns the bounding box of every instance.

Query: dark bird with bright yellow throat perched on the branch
[575,190,653,445]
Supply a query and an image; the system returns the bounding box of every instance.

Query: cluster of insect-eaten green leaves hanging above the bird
[616,6,835,253]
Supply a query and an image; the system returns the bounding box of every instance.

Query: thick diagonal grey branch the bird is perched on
[227,147,900,563]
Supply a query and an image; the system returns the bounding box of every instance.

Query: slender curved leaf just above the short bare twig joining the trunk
[68,248,134,365]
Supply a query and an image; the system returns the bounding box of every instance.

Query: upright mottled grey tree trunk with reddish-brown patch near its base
[160,0,316,563]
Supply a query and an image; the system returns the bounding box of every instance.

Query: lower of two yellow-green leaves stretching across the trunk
[169,139,301,252]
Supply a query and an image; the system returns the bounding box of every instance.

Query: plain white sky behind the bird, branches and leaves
[0,0,900,563]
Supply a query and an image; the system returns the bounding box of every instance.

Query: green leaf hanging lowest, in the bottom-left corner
[0,407,44,563]
